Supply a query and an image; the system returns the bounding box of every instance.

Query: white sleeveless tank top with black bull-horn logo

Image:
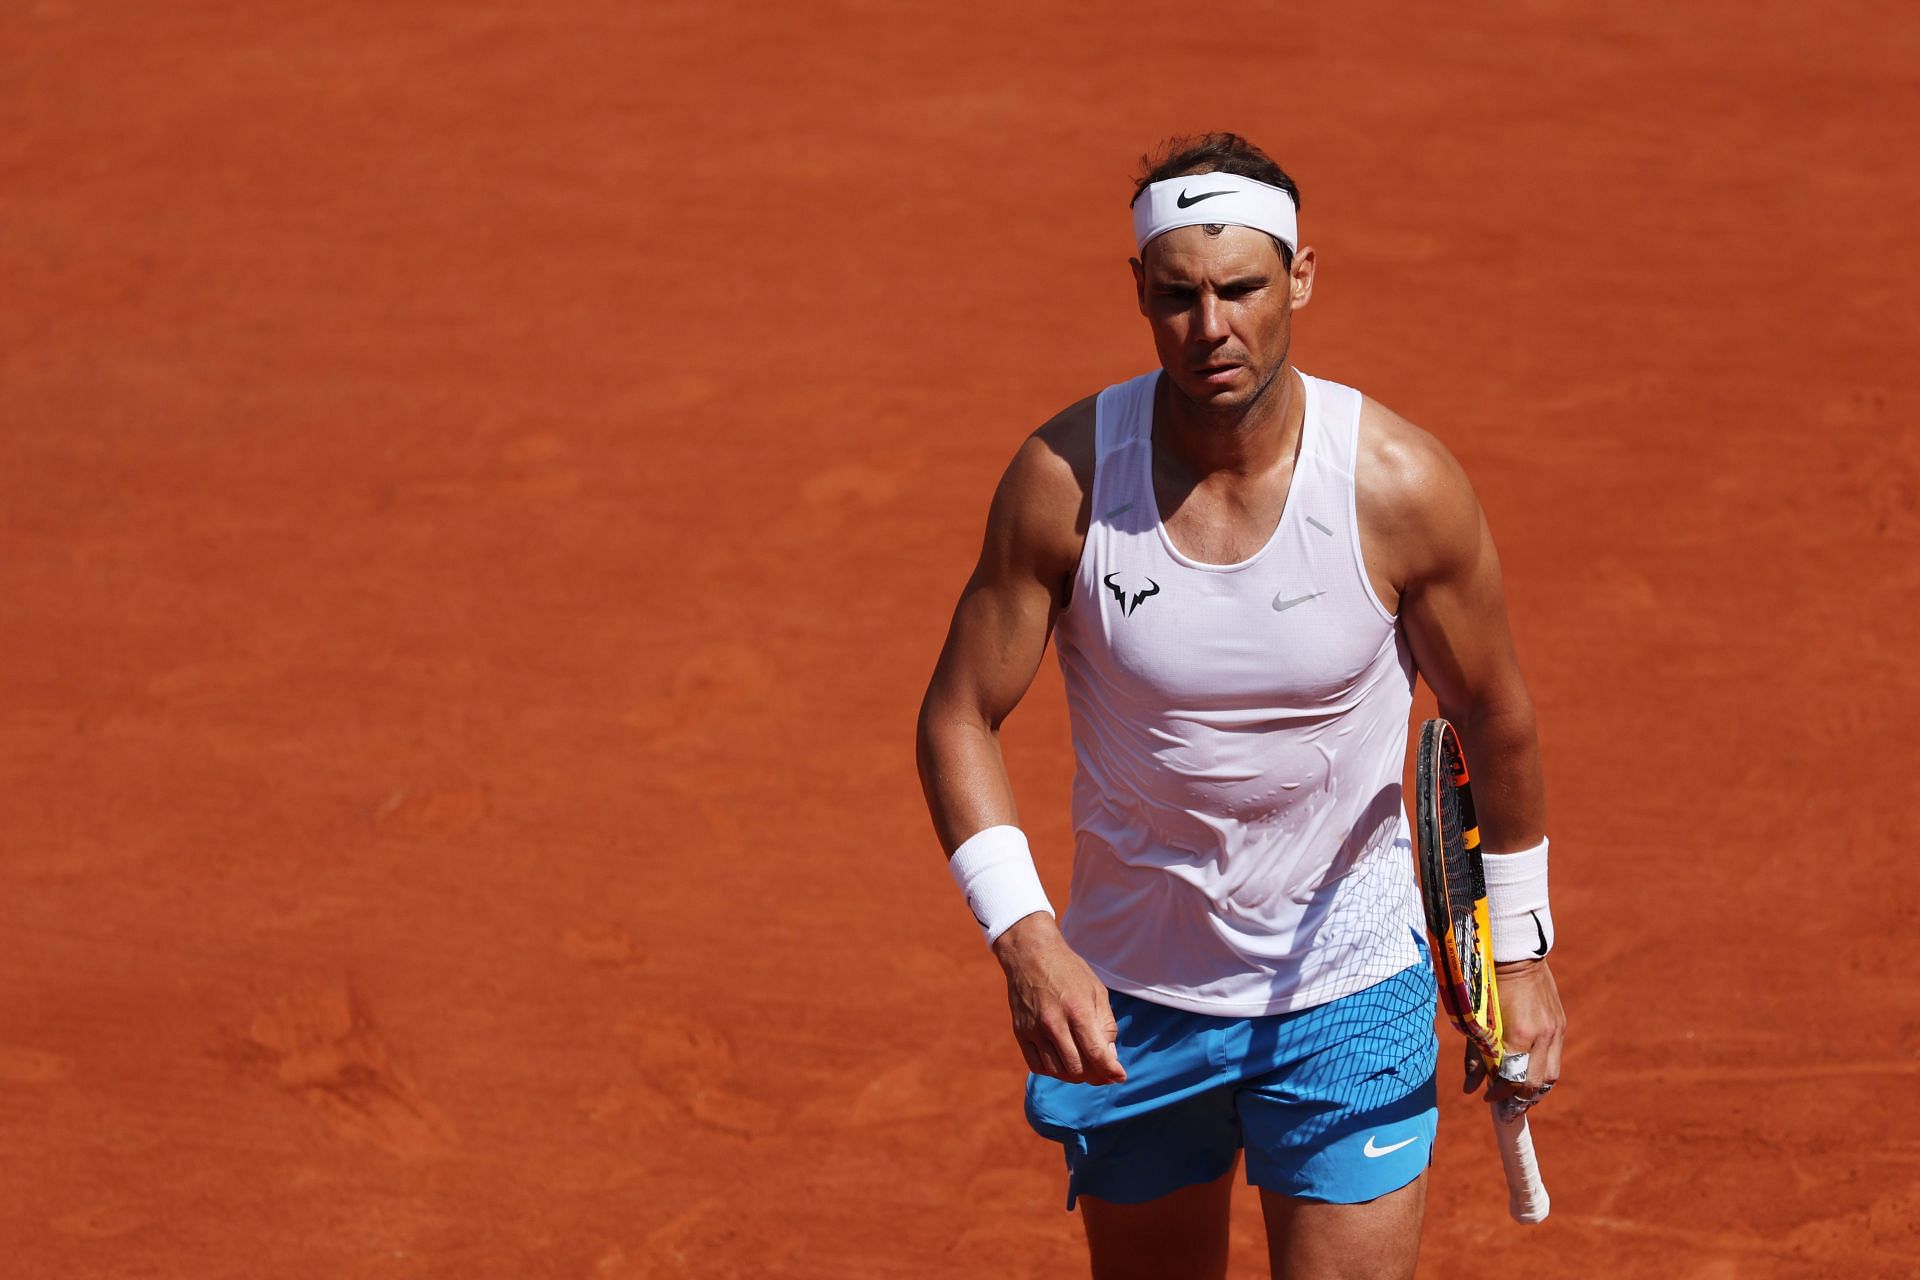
[1054,370,1419,1017]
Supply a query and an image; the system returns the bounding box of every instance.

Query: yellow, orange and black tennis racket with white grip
[1415,720,1549,1222]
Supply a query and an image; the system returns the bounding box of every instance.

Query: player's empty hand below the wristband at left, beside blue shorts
[993,912,1127,1084]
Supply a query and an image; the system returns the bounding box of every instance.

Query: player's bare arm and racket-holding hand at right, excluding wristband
[1357,403,1567,1096]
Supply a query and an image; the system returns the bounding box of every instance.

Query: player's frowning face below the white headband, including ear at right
[1133,226,1313,411]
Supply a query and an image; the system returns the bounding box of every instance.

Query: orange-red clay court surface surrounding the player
[0,0,1920,1280]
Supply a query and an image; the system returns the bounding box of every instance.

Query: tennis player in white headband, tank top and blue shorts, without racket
[918,132,1565,1280]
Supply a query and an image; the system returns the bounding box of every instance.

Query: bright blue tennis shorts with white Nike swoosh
[1027,946,1440,1209]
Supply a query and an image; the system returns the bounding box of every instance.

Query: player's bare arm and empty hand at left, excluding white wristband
[918,399,1125,1084]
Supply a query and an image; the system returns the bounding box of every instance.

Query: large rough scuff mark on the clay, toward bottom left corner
[248,986,459,1159]
